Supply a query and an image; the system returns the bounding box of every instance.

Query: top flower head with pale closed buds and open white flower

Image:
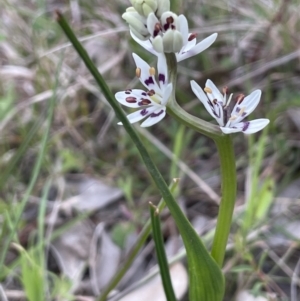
[122,0,217,62]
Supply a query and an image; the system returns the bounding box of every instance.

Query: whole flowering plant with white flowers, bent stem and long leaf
[58,0,269,301]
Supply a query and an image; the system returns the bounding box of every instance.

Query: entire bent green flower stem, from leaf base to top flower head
[166,53,236,267]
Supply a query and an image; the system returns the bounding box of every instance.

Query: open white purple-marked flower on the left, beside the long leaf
[115,53,172,127]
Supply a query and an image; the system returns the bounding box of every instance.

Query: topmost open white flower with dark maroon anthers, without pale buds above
[130,11,218,62]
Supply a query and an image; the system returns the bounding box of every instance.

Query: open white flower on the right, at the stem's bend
[191,80,270,134]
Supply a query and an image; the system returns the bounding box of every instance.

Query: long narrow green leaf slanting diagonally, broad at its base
[57,12,224,301]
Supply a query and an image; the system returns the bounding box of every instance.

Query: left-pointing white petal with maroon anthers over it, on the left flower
[115,89,154,108]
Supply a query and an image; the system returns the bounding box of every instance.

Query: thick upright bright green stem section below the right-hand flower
[211,135,236,267]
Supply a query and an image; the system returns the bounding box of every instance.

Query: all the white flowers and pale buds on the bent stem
[115,0,269,134]
